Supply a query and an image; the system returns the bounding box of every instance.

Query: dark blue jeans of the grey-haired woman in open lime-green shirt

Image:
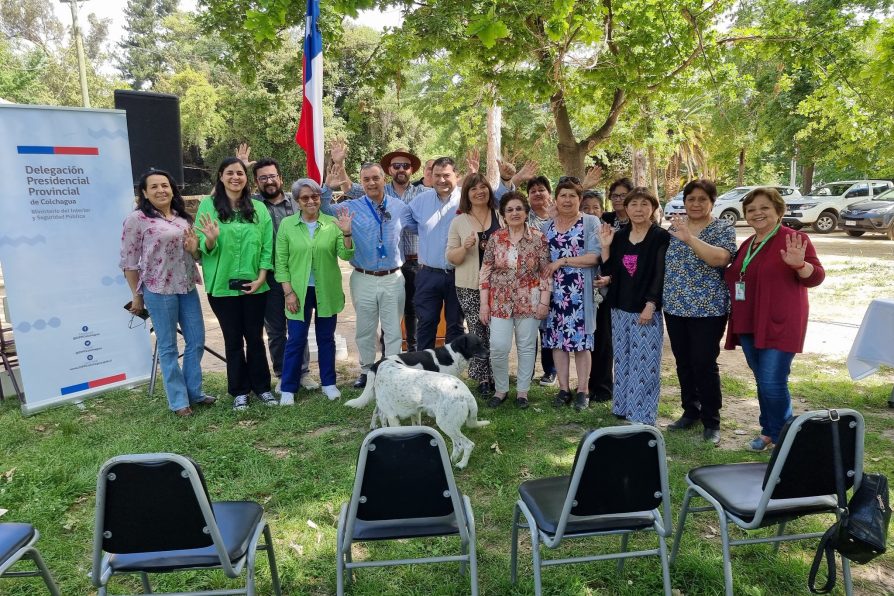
[280,286,338,393]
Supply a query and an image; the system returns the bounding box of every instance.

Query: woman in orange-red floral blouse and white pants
[478,192,552,409]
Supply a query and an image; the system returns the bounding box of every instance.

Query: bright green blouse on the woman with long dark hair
[196,197,273,298]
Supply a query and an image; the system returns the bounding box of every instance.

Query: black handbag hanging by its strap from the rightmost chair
[807,410,891,594]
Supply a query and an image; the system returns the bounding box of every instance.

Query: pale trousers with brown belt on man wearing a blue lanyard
[351,269,406,374]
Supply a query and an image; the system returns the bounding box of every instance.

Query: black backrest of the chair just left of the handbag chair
[572,425,670,527]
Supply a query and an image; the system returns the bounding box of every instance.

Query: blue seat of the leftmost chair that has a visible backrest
[109,501,264,572]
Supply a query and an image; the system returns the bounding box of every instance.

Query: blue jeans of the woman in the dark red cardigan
[739,335,795,443]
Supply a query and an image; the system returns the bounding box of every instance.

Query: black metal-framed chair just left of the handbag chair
[509,424,671,596]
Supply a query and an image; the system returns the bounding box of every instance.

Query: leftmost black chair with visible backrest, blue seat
[91,453,281,596]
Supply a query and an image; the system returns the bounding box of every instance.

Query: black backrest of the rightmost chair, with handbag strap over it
[763,410,864,499]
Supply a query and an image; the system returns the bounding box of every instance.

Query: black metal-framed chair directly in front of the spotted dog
[336,426,478,596]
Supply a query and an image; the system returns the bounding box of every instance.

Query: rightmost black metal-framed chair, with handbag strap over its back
[671,410,864,596]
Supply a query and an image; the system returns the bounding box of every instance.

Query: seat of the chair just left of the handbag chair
[518,476,655,536]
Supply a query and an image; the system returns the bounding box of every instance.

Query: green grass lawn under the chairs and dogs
[0,356,894,596]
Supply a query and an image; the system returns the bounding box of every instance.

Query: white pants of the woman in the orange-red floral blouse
[490,317,540,394]
